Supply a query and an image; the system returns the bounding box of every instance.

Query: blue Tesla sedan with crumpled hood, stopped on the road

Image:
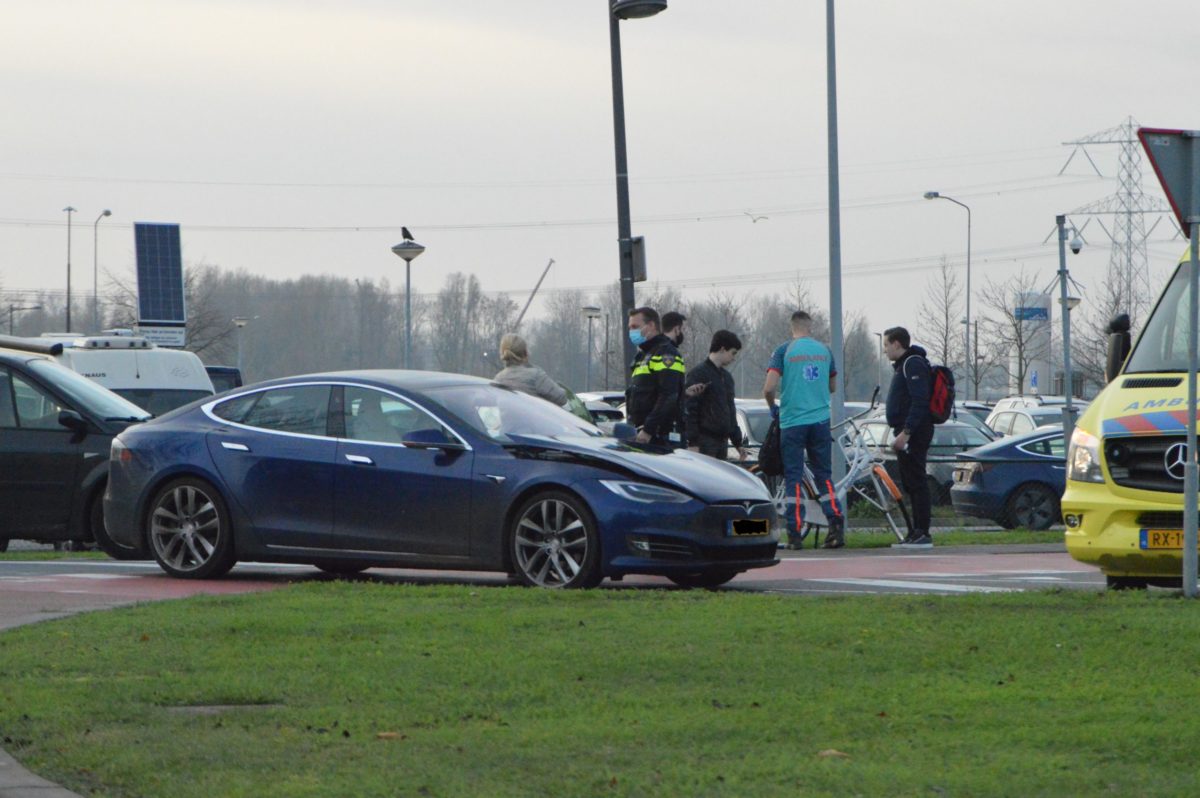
[104,371,778,588]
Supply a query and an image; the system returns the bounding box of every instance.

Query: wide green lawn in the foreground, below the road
[0,582,1200,798]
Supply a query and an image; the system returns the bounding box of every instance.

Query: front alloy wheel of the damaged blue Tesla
[509,491,601,588]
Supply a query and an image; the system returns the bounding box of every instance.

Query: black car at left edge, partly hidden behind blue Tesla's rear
[0,354,150,556]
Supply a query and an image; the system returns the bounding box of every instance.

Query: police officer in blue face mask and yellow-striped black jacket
[625,307,686,446]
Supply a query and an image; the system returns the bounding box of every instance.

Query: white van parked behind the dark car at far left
[0,330,215,415]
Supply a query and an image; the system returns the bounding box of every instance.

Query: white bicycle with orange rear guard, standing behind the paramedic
[760,388,912,547]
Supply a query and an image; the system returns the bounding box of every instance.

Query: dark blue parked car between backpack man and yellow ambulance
[950,426,1067,529]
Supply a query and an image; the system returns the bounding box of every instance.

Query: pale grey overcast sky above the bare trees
[0,0,1200,338]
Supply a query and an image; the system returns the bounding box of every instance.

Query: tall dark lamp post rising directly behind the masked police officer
[605,0,667,379]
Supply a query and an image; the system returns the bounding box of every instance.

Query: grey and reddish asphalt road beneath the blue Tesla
[0,545,1104,629]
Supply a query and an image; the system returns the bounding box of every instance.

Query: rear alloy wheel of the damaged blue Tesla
[146,478,234,580]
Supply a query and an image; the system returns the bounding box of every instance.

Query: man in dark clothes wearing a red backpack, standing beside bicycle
[883,326,953,548]
